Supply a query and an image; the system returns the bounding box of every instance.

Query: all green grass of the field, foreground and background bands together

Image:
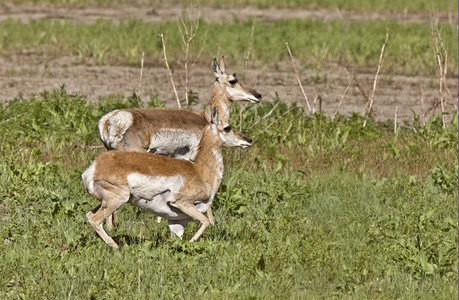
[0,0,459,299]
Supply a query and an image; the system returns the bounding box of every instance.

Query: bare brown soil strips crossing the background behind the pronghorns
[0,2,458,121]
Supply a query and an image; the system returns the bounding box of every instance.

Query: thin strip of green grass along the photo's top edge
[2,0,457,12]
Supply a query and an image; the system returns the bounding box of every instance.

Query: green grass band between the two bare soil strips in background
[0,19,458,76]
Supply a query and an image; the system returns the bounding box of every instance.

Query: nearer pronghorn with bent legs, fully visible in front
[82,107,252,248]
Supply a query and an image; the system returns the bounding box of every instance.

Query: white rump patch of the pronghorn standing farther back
[98,110,134,149]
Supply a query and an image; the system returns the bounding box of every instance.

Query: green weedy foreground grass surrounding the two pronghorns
[0,89,458,299]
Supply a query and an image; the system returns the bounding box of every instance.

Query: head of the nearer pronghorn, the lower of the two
[211,107,252,148]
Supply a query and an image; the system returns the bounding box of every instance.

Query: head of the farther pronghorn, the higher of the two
[212,56,261,103]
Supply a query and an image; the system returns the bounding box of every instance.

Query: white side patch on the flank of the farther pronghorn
[149,129,201,160]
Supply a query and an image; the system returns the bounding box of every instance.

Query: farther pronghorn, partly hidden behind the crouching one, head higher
[98,56,261,229]
